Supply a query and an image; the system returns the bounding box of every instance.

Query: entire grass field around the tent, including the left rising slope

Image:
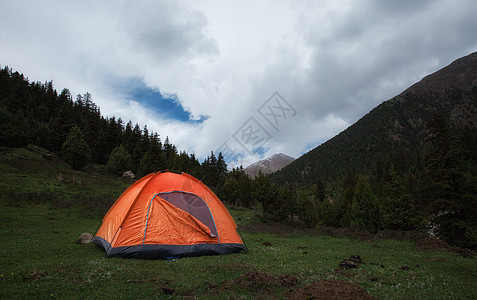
[0,149,477,299]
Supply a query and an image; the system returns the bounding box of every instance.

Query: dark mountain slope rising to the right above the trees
[272,52,477,184]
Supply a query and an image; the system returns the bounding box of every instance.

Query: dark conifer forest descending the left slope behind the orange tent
[0,67,227,186]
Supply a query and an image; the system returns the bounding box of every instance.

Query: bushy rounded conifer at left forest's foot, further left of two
[61,126,91,170]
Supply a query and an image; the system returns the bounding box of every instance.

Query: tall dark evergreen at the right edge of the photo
[426,114,477,248]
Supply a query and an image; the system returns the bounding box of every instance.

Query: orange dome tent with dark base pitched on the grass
[93,172,245,259]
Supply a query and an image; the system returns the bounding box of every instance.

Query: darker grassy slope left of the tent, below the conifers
[0,145,129,217]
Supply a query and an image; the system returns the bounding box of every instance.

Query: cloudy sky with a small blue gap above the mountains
[0,0,477,166]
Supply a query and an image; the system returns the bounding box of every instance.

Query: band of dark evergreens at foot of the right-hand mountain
[260,113,477,249]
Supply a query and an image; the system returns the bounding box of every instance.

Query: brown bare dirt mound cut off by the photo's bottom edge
[288,280,376,300]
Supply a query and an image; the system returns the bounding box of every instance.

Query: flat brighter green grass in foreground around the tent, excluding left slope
[0,204,477,299]
